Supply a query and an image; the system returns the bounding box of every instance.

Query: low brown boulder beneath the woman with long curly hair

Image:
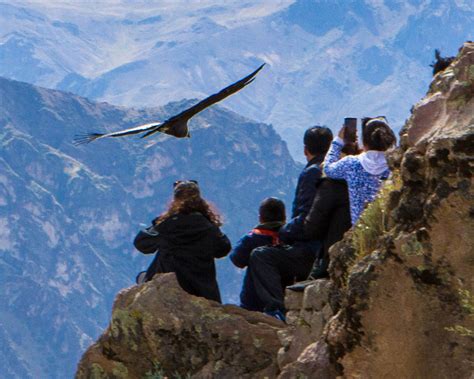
[76,274,284,378]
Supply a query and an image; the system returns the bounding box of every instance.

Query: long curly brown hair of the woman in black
[153,181,222,226]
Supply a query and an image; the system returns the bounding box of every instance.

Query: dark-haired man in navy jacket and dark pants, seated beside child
[249,127,332,320]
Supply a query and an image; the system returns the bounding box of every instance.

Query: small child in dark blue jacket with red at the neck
[230,197,286,312]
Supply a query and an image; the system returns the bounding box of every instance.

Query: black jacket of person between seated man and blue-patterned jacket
[304,178,351,258]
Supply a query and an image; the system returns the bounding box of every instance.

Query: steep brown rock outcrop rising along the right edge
[280,43,474,378]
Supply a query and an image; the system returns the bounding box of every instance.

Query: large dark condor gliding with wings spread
[74,63,265,145]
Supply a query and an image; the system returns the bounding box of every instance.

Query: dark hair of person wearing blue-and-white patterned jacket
[362,116,397,151]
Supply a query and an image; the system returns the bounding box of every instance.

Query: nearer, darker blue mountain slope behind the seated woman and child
[0,79,299,378]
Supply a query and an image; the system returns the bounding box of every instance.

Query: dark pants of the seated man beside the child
[249,245,316,311]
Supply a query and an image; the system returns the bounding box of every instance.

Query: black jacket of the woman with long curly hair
[134,212,231,302]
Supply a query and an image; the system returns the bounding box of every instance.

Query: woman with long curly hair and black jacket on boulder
[134,181,231,302]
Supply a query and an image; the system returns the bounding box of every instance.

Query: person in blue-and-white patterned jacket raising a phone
[323,117,397,225]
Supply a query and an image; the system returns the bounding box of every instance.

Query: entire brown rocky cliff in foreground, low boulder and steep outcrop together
[77,43,474,378]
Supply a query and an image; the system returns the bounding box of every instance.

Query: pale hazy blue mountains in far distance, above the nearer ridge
[0,0,474,158]
